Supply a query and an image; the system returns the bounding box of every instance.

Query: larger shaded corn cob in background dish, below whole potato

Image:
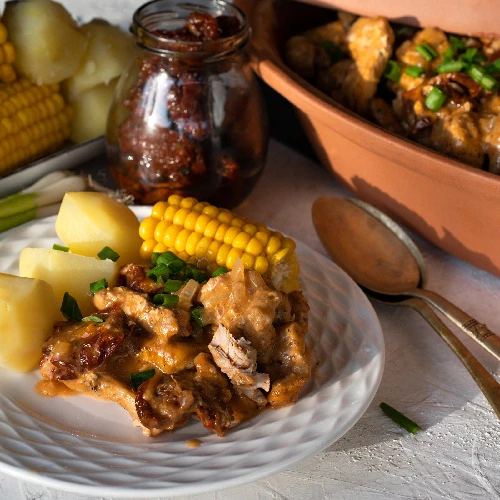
[0,78,71,174]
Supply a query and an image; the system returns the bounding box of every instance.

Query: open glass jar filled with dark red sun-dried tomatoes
[106,0,268,208]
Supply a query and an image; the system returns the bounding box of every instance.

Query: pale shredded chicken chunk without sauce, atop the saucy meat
[208,325,270,406]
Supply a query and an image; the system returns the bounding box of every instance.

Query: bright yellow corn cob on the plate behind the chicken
[139,195,299,293]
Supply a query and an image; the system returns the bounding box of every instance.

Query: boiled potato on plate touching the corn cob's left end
[56,191,141,264]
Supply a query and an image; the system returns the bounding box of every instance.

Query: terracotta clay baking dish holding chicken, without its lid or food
[252,0,500,282]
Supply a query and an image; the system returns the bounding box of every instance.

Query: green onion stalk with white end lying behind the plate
[0,171,87,232]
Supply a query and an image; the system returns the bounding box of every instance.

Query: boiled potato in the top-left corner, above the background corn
[3,0,87,84]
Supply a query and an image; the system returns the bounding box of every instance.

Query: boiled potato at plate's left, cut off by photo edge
[0,273,62,372]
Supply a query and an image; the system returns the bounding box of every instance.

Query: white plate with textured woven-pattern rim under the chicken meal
[0,207,384,498]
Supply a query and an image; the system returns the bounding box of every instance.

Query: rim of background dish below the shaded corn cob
[0,137,104,198]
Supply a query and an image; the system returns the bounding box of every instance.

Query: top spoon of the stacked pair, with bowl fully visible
[312,196,500,360]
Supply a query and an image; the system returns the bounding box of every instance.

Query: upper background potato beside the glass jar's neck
[64,19,135,101]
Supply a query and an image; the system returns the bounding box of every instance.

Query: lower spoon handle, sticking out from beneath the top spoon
[398,298,500,418]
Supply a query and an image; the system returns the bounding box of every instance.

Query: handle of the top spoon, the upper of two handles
[412,289,500,361]
